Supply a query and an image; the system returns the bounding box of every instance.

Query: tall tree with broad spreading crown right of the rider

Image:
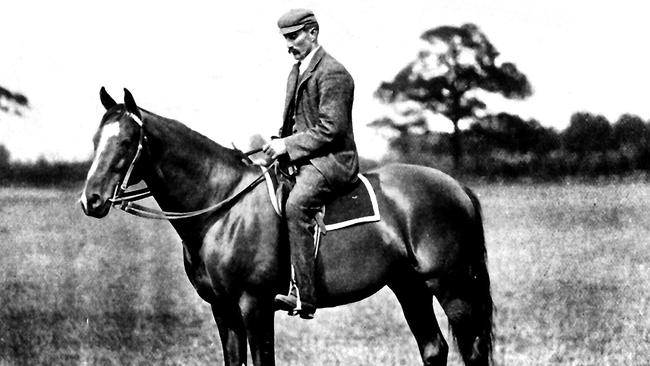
[375,23,532,168]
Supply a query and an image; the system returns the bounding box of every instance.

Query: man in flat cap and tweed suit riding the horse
[263,9,359,319]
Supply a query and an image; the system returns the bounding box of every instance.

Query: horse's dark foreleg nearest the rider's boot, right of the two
[239,294,275,366]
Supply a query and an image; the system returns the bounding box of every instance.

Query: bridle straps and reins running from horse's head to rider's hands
[108,111,275,220]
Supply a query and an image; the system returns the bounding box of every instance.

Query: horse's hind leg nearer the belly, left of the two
[389,275,449,366]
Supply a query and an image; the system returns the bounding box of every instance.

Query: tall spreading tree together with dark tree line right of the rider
[369,23,650,178]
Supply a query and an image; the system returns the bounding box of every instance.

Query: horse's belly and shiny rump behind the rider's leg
[318,164,474,306]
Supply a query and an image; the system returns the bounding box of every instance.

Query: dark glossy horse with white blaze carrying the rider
[81,88,493,366]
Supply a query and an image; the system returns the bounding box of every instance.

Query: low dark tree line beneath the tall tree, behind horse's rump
[373,112,650,179]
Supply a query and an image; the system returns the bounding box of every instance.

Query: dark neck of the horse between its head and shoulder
[143,114,244,216]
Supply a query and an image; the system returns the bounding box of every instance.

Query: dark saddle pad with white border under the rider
[264,167,380,231]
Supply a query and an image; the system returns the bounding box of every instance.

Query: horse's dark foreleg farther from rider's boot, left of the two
[212,304,246,366]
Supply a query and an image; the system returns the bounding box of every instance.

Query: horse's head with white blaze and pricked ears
[80,87,143,218]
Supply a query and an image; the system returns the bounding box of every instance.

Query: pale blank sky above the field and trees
[0,0,650,161]
